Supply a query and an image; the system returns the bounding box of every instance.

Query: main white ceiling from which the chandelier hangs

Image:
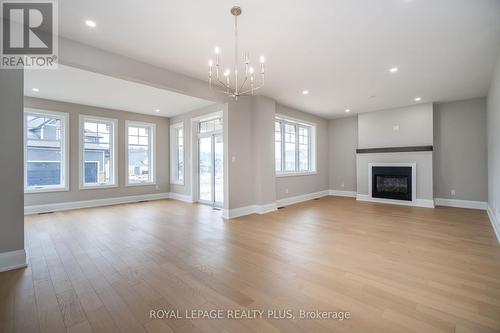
[54,0,500,117]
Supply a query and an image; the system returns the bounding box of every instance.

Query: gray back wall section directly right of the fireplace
[434,98,488,202]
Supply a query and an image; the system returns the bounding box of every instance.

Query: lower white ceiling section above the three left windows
[24,65,213,117]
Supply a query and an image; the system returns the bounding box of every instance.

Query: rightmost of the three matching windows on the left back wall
[126,121,155,186]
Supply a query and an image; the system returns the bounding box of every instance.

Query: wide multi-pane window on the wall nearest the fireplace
[274,116,316,176]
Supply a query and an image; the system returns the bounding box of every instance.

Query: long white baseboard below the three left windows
[24,193,170,215]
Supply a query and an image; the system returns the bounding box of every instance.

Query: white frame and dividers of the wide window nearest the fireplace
[273,114,317,177]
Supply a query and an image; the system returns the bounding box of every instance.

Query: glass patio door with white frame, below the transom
[198,133,224,207]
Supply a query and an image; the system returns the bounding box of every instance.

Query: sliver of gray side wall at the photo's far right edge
[486,50,500,230]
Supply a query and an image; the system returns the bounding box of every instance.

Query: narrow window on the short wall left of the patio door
[170,123,184,185]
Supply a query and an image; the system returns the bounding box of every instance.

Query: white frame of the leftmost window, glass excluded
[23,108,69,194]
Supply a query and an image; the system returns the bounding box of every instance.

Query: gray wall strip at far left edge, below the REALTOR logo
[0,69,24,254]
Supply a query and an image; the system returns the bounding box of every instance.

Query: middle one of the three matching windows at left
[80,116,117,188]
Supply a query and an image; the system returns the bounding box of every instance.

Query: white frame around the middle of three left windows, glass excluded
[78,114,118,190]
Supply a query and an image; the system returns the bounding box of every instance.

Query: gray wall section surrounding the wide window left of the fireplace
[276,104,330,200]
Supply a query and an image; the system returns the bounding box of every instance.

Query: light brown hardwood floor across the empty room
[0,197,500,333]
